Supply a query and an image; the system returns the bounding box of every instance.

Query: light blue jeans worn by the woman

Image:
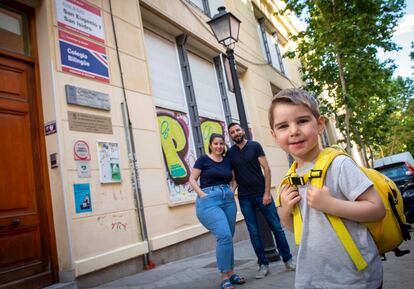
[196,185,237,273]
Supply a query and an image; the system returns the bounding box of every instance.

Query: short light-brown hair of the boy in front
[269,88,321,129]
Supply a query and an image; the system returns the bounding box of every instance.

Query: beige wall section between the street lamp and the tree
[234,0,301,184]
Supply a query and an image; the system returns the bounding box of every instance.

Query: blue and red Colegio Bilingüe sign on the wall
[58,30,109,83]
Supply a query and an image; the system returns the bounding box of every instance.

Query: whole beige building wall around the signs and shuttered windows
[37,0,300,278]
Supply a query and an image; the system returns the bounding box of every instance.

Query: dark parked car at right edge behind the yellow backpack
[375,162,414,223]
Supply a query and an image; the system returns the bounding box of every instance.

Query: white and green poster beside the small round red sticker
[97,141,121,184]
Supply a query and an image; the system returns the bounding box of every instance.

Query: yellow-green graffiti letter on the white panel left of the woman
[157,108,197,204]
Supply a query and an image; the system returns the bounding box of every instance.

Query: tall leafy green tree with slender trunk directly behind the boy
[282,0,405,160]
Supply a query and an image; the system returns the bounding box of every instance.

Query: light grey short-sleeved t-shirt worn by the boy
[295,156,382,289]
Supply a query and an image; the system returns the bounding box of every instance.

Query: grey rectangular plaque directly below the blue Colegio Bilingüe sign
[65,84,111,111]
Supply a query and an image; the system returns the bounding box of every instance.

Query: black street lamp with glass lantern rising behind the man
[207,6,250,139]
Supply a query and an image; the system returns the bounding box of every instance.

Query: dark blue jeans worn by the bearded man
[239,196,292,265]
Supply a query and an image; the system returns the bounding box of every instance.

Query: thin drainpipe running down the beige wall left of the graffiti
[109,0,155,270]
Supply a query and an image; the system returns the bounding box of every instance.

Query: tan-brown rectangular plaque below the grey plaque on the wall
[68,111,112,134]
